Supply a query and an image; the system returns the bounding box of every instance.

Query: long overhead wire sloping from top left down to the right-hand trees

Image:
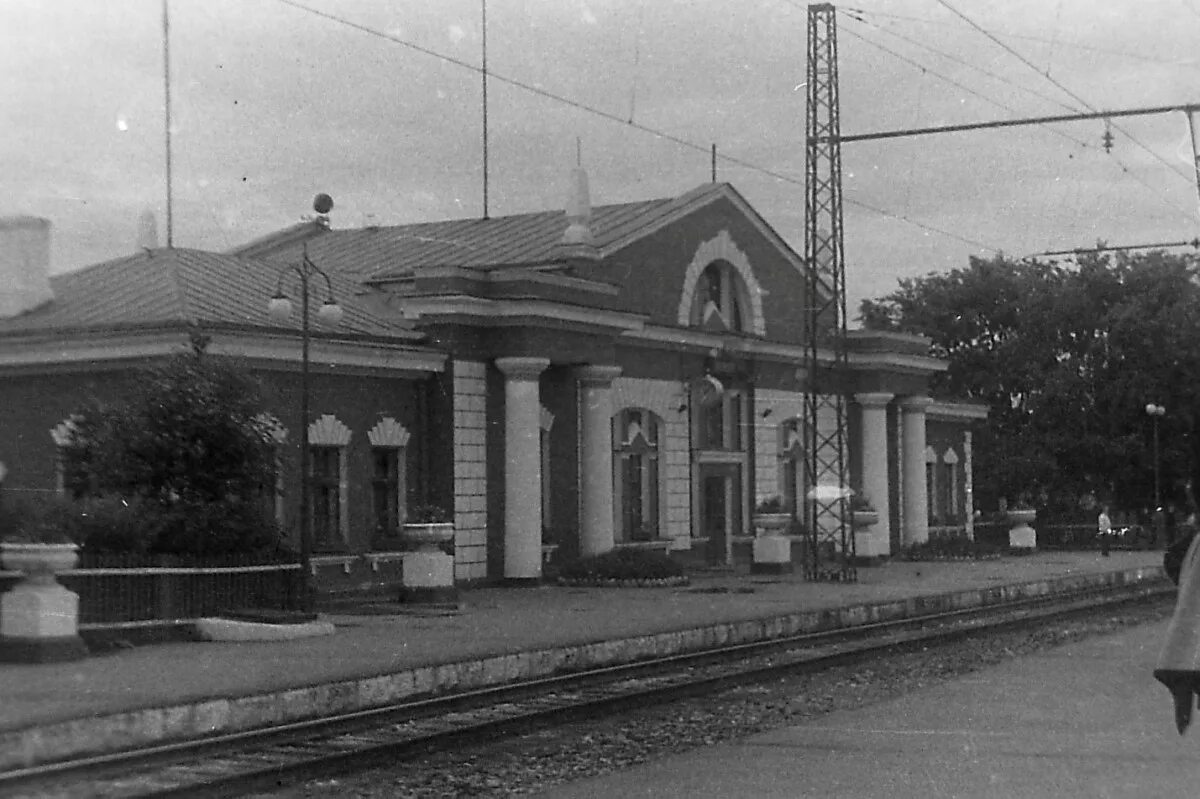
[278,0,1001,252]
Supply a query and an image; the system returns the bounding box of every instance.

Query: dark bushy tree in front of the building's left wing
[72,335,278,554]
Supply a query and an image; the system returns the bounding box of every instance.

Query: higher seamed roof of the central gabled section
[226,184,727,281]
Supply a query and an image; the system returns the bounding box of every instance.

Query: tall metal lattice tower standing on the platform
[804,4,857,581]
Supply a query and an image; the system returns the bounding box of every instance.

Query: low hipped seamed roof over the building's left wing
[0,248,409,337]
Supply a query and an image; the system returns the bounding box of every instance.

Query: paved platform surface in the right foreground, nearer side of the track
[541,607,1200,799]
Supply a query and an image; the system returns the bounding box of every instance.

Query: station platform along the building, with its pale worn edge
[0,552,1164,773]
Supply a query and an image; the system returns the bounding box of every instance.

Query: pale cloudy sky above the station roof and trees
[0,0,1200,319]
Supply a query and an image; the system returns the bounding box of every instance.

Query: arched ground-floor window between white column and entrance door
[612,408,662,541]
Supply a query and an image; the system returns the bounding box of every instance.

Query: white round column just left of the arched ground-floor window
[576,366,620,555]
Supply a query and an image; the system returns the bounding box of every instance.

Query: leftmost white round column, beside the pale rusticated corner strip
[496,358,550,579]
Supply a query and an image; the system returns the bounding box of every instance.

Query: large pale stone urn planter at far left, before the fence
[0,541,88,663]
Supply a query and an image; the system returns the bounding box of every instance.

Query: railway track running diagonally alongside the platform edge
[0,582,1175,798]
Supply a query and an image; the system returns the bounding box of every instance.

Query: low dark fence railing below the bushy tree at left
[0,553,304,630]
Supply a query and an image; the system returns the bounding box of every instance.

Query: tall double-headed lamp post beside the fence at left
[266,236,343,613]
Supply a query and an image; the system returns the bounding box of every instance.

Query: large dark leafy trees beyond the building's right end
[862,251,1200,509]
